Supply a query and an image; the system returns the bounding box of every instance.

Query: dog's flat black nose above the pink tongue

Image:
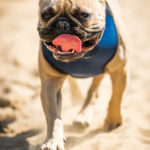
[56,20,70,30]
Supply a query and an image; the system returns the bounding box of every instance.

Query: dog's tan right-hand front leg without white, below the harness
[104,68,127,130]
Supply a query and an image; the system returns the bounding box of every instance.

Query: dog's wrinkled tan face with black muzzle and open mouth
[38,0,106,62]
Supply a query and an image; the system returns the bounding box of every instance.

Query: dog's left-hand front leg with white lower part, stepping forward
[41,77,64,150]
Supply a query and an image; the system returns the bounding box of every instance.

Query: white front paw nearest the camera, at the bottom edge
[40,138,64,150]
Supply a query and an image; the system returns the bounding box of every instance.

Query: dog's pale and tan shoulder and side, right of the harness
[106,0,129,72]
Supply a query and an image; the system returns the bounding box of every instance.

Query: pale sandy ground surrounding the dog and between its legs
[0,0,150,150]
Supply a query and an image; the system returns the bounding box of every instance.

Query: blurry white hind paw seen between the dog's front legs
[73,110,93,128]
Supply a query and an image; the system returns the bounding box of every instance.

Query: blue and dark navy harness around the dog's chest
[42,6,118,78]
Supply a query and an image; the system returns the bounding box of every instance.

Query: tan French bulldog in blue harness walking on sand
[38,0,127,150]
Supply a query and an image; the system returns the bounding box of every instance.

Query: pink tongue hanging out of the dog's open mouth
[52,34,82,53]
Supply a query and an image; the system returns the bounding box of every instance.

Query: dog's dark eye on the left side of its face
[41,7,55,21]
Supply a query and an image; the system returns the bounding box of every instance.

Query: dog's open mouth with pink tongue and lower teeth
[44,34,97,57]
